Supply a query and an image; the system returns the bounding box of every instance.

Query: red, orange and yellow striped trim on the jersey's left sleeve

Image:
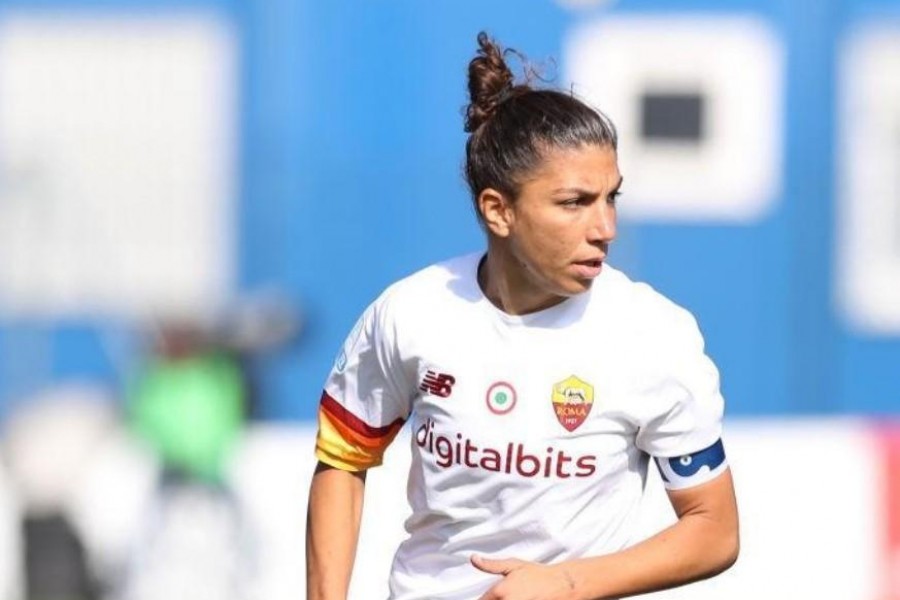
[316,391,405,471]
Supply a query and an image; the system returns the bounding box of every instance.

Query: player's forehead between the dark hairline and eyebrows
[523,145,619,188]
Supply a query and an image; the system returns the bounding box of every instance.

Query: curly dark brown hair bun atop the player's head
[465,31,515,133]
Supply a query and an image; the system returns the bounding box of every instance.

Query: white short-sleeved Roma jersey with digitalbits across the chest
[317,255,726,600]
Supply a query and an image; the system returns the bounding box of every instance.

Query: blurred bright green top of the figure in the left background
[129,353,244,483]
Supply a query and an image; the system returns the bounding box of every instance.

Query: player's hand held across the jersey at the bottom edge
[471,556,577,600]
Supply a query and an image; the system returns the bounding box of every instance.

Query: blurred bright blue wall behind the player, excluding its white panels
[0,0,900,421]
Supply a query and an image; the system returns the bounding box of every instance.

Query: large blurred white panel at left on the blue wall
[0,12,237,315]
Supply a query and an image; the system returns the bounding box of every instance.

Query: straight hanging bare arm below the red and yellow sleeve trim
[306,462,366,600]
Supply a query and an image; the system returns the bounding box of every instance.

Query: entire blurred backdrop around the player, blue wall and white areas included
[0,0,900,600]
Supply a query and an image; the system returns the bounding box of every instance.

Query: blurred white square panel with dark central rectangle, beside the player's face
[564,14,784,222]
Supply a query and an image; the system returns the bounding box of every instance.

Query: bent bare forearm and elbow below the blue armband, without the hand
[558,473,739,600]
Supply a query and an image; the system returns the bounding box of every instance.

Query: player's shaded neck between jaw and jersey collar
[478,240,565,315]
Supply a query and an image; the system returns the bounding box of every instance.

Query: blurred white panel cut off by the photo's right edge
[835,22,900,335]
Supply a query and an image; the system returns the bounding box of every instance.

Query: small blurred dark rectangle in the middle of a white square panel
[641,92,705,143]
